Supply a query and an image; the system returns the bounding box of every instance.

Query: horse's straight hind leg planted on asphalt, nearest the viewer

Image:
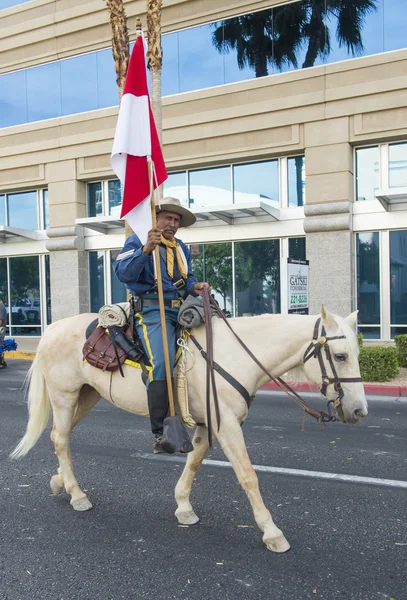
[48,388,92,511]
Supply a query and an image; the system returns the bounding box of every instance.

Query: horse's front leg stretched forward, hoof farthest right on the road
[214,411,290,552]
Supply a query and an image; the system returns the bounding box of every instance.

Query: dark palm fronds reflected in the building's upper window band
[212,0,377,77]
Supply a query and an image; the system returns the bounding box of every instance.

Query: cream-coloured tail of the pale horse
[10,356,50,459]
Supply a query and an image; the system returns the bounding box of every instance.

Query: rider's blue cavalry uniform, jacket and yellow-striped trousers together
[114,234,197,384]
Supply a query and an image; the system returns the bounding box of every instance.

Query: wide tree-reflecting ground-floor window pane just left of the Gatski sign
[235,240,280,316]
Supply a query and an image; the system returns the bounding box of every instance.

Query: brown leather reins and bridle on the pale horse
[196,288,362,434]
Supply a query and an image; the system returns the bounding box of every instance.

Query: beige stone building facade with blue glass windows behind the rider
[0,0,407,341]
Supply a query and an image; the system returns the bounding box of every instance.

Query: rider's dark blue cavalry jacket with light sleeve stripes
[113,233,197,296]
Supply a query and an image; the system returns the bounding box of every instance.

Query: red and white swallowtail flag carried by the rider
[110,35,168,244]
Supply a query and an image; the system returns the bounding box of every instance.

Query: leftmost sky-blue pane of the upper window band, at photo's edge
[0,71,27,127]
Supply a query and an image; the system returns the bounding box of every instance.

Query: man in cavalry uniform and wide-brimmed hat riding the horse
[114,198,210,453]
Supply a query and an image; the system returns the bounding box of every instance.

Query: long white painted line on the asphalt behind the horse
[131,452,407,489]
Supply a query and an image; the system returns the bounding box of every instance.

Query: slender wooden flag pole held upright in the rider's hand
[147,158,175,417]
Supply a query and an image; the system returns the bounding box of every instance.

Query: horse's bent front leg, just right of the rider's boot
[175,426,209,525]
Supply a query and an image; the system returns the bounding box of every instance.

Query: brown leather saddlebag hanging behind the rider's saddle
[82,327,129,371]
